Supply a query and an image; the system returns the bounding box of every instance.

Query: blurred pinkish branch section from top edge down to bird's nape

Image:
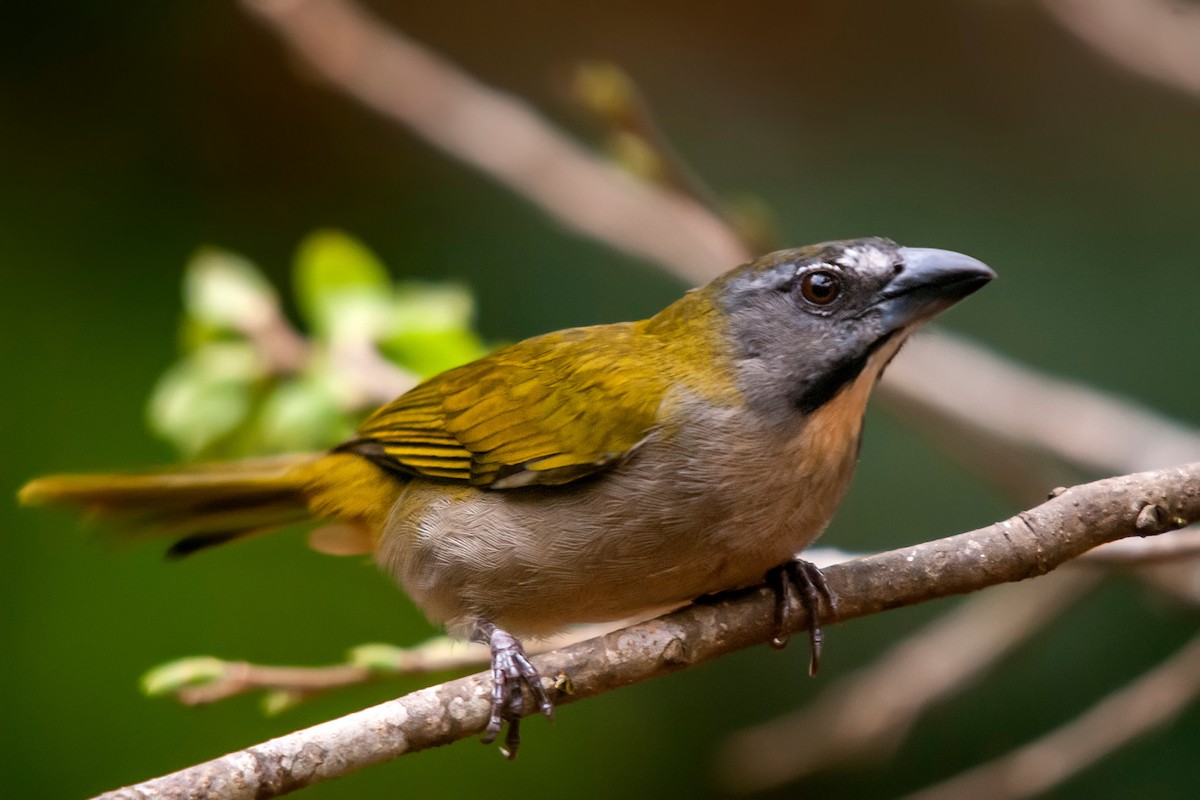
[245,0,750,281]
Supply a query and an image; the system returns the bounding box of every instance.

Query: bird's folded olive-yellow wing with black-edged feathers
[346,324,666,488]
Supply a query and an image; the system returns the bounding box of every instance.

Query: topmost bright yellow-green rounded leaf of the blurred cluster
[294,230,392,341]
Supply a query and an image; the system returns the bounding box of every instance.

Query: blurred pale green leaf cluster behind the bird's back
[148,230,487,458]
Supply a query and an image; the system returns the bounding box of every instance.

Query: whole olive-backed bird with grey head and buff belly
[19,237,995,758]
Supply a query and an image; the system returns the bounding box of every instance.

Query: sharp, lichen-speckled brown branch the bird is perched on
[101,463,1200,800]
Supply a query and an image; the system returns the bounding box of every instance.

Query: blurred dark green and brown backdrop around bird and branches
[0,0,1200,798]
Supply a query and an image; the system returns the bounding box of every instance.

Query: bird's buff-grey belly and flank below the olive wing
[378,417,857,634]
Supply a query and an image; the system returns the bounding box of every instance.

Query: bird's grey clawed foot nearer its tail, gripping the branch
[470,621,554,759]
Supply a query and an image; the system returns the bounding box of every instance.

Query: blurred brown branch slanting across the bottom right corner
[907,637,1200,800]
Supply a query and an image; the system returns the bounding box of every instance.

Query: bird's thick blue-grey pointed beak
[875,247,996,331]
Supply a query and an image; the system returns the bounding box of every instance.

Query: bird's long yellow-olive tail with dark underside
[18,453,329,555]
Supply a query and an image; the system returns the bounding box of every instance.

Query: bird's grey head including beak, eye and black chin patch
[709,239,996,419]
